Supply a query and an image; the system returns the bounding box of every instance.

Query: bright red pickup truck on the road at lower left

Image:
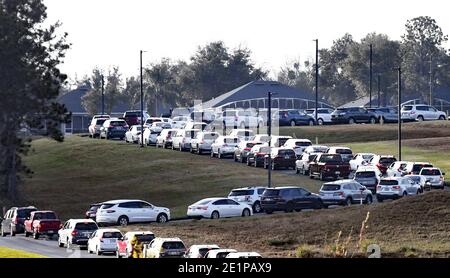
[24,210,61,239]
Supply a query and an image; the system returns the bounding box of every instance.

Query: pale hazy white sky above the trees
[44,0,450,78]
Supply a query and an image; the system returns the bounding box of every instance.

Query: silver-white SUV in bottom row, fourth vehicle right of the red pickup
[143,237,186,258]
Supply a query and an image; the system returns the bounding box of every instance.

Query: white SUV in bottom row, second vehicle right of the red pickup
[87,229,122,256]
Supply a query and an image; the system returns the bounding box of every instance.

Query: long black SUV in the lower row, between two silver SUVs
[261,186,324,214]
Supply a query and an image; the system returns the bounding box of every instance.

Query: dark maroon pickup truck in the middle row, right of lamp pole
[309,153,350,180]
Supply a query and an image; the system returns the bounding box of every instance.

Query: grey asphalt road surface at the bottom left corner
[0,234,111,258]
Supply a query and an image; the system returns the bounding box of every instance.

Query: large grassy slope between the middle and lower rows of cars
[21,136,320,219]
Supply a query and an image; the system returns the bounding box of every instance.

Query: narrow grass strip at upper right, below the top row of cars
[279,121,450,144]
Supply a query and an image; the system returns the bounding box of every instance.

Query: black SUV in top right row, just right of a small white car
[331,107,377,124]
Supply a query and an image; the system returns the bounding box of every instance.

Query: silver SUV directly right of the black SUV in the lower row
[319,180,373,207]
